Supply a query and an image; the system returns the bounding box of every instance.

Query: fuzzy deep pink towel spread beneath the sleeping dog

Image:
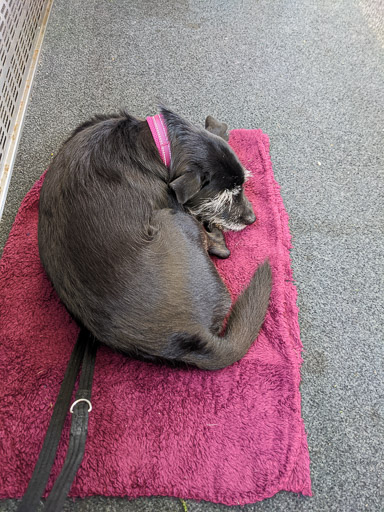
[0,130,311,505]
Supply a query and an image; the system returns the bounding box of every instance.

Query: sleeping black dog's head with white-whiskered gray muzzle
[161,107,256,231]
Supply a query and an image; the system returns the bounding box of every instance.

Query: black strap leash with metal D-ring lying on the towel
[17,329,98,512]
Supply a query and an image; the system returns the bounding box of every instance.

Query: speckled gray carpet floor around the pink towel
[0,0,384,512]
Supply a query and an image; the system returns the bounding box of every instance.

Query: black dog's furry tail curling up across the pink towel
[173,261,272,370]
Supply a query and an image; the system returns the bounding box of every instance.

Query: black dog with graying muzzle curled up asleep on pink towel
[38,107,272,370]
